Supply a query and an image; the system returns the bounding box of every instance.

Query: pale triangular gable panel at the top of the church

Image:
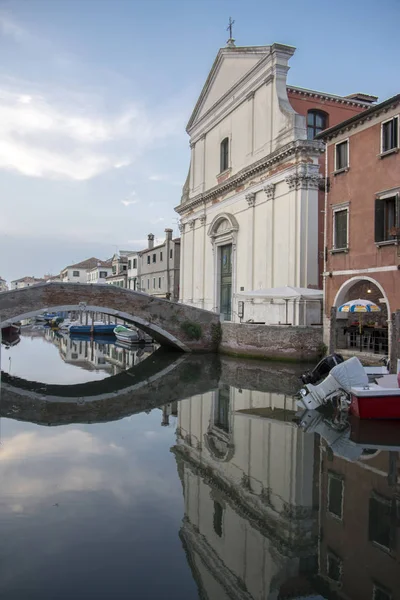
[186,46,270,130]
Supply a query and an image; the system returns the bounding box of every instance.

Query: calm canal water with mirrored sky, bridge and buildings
[0,327,400,600]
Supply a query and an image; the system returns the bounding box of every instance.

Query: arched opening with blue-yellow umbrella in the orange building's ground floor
[334,277,390,356]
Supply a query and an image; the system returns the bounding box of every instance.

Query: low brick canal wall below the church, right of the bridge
[219,321,324,362]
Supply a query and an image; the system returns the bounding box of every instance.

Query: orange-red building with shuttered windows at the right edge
[317,94,400,349]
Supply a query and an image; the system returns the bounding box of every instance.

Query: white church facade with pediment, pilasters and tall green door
[176,40,323,323]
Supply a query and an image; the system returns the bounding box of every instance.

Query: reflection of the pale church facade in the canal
[174,386,317,600]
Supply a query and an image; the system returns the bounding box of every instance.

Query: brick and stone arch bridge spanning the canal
[0,282,220,352]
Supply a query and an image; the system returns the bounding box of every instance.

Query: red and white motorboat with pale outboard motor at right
[298,356,400,419]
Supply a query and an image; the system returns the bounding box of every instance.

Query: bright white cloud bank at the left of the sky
[0,85,183,181]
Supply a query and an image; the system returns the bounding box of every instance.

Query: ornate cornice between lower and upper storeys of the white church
[175,140,325,215]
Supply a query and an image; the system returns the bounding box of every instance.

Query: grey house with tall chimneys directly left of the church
[139,229,181,300]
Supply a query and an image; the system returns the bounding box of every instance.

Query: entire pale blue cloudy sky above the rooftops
[0,0,400,280]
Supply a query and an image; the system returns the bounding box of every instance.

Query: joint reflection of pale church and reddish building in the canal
[173,385,400,600]
